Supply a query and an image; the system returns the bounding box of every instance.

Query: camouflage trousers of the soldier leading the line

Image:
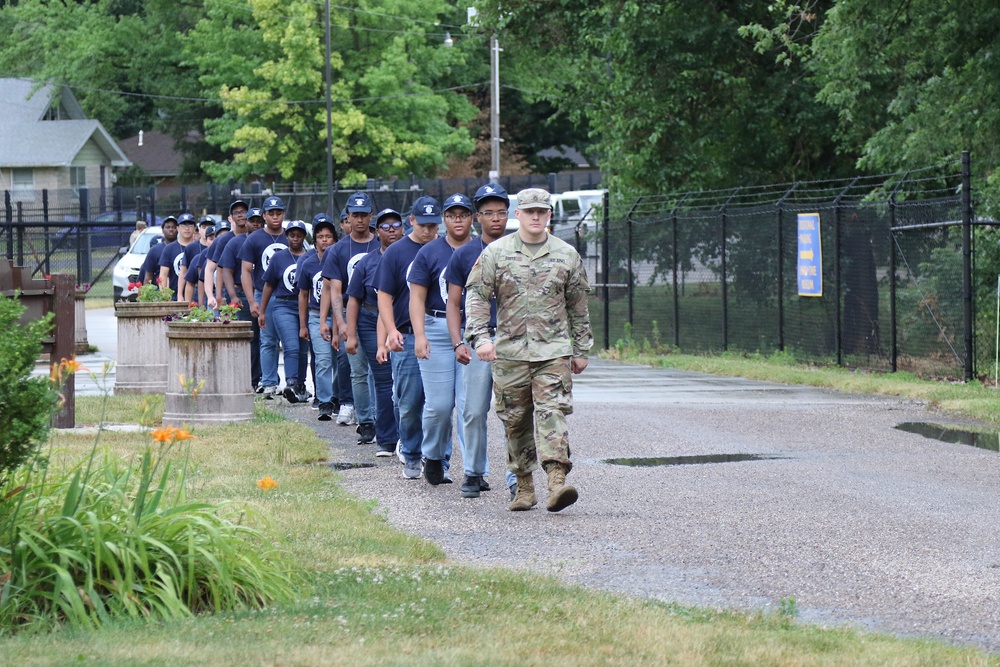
[493,357,573,475]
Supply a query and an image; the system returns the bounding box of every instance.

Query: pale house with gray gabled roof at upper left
[0,79,132,212]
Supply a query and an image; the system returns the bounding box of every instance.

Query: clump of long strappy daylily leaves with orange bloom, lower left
[0,429,292,634]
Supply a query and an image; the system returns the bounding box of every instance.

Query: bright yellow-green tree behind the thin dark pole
[190,0,475,183]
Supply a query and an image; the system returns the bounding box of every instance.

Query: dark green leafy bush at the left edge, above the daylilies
[0,295,57,480]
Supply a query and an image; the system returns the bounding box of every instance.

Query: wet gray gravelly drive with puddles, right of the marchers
[284,360,1000,651]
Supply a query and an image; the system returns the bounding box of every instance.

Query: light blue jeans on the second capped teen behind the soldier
[419,315,465,467]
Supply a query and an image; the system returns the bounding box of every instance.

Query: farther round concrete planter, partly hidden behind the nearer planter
[115,301,190,394]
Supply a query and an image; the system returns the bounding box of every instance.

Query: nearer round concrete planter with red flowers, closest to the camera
[163,321,253,426]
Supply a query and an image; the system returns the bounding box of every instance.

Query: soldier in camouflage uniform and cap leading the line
[465,188,594,512]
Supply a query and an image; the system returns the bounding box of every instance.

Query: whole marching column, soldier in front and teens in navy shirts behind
[140,183,593,512]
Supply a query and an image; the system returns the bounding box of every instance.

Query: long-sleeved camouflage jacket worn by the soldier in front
[465,234,594,361]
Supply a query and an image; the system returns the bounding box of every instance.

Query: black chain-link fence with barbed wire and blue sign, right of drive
[588,154,1000,379]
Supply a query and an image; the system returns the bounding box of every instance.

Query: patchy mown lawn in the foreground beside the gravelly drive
[0,396,1000,667]
